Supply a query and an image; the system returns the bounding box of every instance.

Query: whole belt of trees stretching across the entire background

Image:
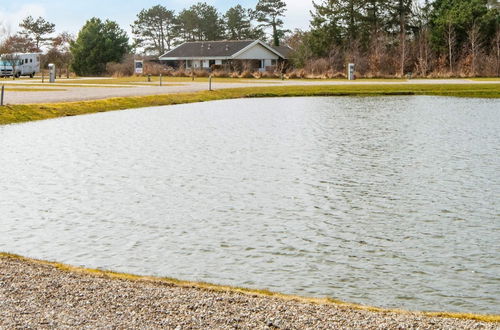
[0,0,500,78]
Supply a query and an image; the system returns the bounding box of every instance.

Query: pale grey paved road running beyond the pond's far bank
[0,79,500,104]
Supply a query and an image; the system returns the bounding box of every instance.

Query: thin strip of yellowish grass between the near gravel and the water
[0,252,500,323]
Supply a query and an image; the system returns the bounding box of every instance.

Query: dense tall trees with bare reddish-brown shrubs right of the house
[287,0,500,77]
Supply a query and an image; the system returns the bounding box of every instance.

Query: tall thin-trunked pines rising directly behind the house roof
[132,0,287,55]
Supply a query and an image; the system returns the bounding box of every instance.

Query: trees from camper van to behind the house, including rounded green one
[0,0,287,75]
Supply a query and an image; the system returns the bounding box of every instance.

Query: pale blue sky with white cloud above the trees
[0,0,312,35]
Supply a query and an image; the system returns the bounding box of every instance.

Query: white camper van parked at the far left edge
[0,53,40,78]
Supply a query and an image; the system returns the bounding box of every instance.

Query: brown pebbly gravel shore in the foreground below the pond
[0,255,500,329]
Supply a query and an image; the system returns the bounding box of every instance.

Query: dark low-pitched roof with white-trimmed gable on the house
[160,40,289,60]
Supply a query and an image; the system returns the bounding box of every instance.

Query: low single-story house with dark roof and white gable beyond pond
[160,40,292,71]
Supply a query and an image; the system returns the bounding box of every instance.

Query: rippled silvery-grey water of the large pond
[0,96,500,314]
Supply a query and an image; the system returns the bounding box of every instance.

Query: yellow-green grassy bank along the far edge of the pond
[0,84,500,125]
